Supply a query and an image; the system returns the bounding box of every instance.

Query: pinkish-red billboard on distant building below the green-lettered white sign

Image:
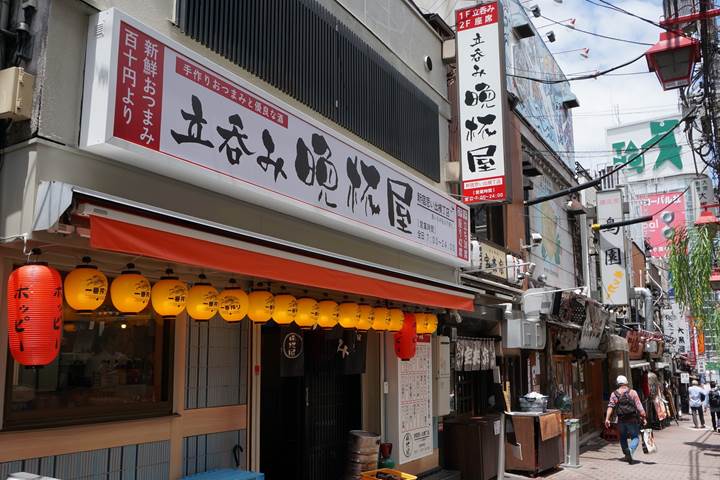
[638,192,685,258]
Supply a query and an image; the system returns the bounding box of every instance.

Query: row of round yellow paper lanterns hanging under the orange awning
[49,257,437,334]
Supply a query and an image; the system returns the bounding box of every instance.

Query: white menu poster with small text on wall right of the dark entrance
[398,335,433,465]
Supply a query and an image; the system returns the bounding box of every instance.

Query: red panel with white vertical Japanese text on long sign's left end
[113,22,165,150]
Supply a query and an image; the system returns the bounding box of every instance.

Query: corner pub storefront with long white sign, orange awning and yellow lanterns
[0,0,476,479]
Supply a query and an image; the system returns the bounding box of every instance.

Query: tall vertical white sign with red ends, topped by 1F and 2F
[455,2,510,204]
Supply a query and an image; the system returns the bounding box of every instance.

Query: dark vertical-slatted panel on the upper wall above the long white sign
[177,0,440,181]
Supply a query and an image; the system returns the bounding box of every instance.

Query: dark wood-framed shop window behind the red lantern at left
[4,272,174,429]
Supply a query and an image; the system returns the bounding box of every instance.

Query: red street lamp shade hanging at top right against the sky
[645,32,700,90]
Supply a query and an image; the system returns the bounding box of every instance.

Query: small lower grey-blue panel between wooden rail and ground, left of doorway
[183,430,247,475]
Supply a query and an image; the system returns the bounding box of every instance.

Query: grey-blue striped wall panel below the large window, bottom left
[0,441,170,480]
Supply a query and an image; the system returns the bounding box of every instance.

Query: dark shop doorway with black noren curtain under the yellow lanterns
[260,325,364,480]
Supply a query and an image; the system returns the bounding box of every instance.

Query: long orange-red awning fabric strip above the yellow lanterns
[90,213,474,311]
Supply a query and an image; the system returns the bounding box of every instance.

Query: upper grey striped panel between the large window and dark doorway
[185,317,249,409]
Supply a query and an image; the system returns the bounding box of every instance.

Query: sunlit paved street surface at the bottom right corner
[545,415,720,480]
